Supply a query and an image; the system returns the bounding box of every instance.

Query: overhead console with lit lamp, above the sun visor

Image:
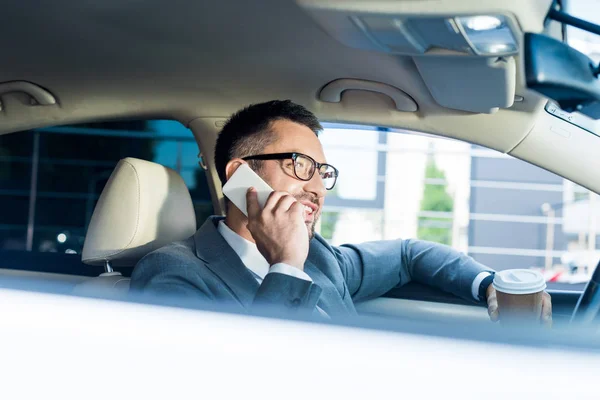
[292,9,519,57]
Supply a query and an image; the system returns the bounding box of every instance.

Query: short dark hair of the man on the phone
[215,100,323,185]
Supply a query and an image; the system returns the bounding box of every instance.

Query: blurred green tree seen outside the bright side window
[417,157,454,245]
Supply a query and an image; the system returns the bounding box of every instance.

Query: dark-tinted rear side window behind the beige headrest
[0,120,213,253]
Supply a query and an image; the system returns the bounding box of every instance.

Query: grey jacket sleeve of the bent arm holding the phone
[131,252,321,314]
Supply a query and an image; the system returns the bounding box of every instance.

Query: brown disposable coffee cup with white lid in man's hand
[492,269,546,324]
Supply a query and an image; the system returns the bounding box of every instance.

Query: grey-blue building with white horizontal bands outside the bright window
[469,147,568,269]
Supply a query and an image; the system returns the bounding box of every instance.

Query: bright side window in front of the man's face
[319,125,600,290]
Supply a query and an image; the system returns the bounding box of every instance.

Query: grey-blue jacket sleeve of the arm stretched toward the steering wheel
[332,239,492,301]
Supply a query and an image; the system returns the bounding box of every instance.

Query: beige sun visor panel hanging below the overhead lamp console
[413,55,516,114]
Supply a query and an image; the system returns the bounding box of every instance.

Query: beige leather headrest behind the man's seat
[82,158,196,266]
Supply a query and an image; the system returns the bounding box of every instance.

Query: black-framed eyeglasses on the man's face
[242,153,339,190]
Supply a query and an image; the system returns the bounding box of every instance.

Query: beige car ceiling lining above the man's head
[0,0,551,152]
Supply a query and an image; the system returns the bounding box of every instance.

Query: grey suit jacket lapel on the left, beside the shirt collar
[194,217,259,307]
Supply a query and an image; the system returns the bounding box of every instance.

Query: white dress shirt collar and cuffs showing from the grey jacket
[217,220,490,304]
